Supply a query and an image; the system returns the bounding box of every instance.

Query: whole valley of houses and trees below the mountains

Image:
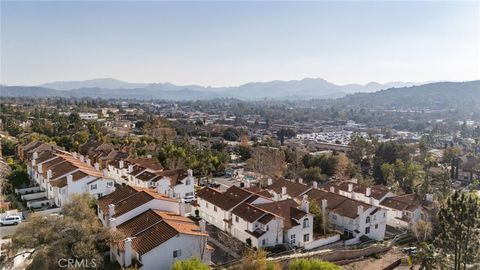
[0,87,480,269]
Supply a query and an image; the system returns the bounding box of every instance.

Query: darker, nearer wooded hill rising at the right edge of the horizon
[336,81,480,109]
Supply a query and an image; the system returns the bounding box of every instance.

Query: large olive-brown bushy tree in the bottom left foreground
[12,194,114,269]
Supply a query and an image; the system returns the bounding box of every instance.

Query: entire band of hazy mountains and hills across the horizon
[0,79,474,105]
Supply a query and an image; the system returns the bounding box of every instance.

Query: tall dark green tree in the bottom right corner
[435,191,480,270]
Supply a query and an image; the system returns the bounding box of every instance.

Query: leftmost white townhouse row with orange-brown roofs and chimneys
[27,149,115,207]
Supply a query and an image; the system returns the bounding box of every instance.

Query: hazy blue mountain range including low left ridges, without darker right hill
[1,78,415,100]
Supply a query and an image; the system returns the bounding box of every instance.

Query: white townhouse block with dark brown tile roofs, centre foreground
[196,186,313,248]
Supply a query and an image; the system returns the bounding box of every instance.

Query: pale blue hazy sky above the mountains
[0,1,480,86]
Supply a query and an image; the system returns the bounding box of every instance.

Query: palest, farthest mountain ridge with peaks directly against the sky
[27,78,420,99]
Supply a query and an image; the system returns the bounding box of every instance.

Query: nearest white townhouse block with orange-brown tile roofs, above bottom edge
[97,186,212,270]
